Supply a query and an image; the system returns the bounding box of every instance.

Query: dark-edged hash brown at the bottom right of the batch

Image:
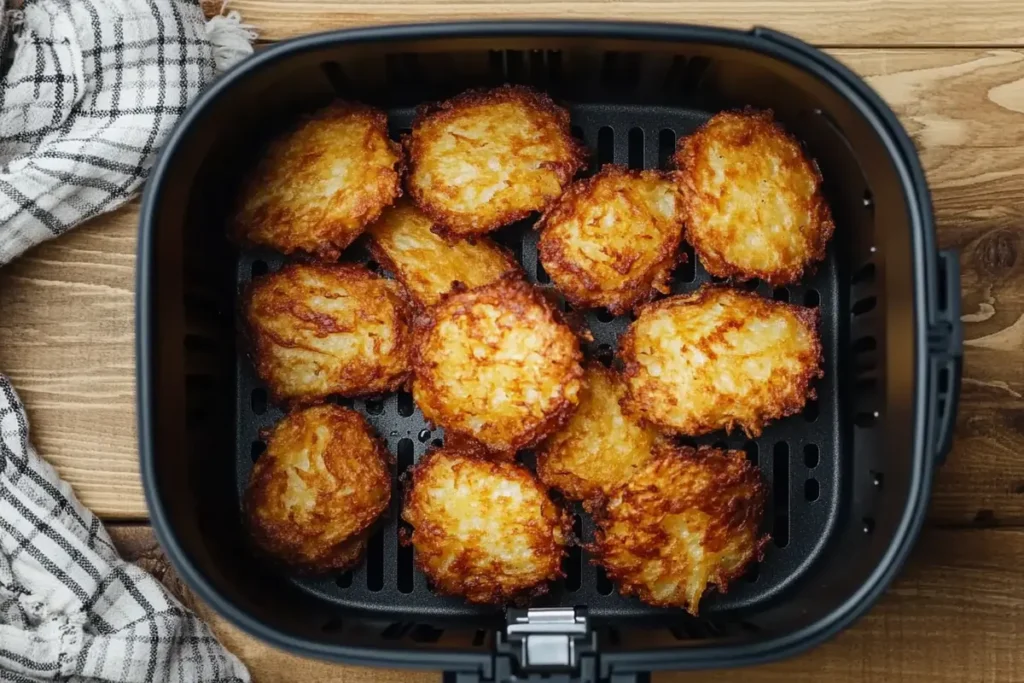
[588,445,768,615]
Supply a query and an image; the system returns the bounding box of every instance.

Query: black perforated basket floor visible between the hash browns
[236,104,844,623]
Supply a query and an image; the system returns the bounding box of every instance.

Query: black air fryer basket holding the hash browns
[137,23,962,681]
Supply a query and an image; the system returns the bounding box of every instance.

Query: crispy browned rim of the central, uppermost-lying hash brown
[412,276,584,458]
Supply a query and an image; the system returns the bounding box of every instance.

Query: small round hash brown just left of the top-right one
[537,165,684,315]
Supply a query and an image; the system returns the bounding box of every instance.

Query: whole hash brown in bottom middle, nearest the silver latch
[402,449,572,604]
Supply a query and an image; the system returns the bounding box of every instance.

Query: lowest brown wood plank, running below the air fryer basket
[110,525,1024,683]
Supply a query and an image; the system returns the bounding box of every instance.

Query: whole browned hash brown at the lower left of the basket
[245,404,391,571]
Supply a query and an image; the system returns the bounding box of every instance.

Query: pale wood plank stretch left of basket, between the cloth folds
[0,208,145,518]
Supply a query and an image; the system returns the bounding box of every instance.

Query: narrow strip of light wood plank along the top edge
[230,0,1024,46]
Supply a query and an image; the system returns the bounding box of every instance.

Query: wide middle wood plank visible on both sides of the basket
[0,49,1024,524]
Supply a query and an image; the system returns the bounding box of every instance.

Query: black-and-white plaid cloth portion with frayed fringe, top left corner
[0,0,251,265]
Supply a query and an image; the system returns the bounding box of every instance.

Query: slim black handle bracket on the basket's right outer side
[928,250,964,464]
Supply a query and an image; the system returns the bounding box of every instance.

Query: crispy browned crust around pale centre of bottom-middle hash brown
[401,443,573,604]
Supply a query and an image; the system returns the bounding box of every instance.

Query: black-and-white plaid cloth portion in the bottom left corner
[0,376,249,683]
